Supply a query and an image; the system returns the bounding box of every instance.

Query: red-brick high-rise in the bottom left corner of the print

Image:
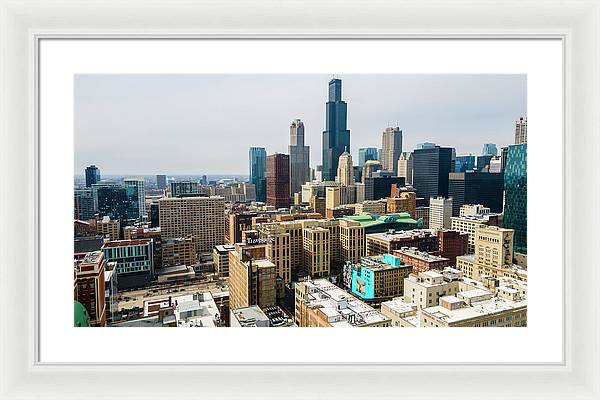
[75,251,106,326]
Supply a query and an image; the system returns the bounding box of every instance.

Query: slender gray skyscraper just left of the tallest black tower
[288,119,310,193]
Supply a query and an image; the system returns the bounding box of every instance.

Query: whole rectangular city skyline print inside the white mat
[72,71,536,332]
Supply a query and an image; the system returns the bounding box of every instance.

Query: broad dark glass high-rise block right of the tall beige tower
[413,146,454,201]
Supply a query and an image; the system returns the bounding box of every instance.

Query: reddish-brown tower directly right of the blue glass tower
[267,153,290,208]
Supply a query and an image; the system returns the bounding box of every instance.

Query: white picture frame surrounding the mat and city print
[0,0,600,399]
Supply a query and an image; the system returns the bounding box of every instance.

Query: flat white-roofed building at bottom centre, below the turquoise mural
[295,279,391,328]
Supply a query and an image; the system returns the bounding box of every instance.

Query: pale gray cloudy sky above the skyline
[74,74,527,175]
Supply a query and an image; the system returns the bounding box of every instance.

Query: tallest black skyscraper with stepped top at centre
[323,79,350,181]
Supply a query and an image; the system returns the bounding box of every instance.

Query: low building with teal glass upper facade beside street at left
[102,239,154,289]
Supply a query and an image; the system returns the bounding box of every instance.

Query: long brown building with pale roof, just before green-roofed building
[366,229,439,256]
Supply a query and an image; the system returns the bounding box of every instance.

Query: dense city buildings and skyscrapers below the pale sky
[73,76,527,328]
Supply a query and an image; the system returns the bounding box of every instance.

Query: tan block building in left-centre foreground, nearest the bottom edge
[229,243,277,308]
